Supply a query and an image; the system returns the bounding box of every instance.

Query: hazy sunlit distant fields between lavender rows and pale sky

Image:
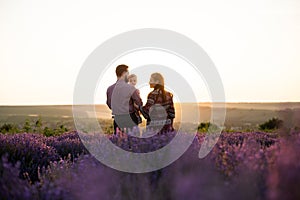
[0,103,300,130]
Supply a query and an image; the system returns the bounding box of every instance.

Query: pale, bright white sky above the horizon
[0,0,300,105]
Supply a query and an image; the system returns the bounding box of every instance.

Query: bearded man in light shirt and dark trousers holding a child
[106,64,143,134]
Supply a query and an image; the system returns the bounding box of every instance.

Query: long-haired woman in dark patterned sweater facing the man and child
[140,73,175,132]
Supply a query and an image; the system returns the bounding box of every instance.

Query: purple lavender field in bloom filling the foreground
[0,131,300,199]
